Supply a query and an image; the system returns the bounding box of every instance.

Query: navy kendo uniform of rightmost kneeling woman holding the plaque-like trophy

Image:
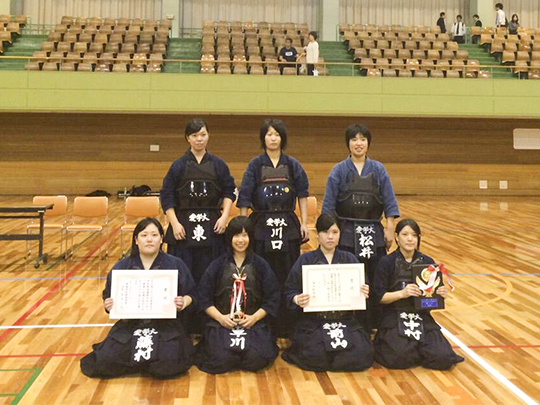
[373,249,464,370]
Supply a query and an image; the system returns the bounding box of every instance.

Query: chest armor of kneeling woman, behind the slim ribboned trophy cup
[214,262,262,315]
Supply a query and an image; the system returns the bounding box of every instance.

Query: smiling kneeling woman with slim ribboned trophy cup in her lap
[196,216,280,374]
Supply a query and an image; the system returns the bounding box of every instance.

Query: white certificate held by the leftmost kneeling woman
[109,270,178,319]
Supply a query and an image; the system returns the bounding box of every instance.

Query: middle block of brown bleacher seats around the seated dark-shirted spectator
[201,21,309,75]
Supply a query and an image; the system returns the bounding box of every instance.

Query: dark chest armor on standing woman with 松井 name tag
[336,173,384,221]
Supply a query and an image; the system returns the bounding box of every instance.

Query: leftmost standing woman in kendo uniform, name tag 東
[161,119,236,283]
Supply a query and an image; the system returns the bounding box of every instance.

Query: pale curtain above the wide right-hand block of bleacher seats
[340,0,470,28]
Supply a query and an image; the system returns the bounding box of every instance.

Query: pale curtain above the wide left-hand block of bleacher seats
[19,0,162,24]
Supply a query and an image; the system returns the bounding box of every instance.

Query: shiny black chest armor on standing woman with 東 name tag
[176,161,222,210]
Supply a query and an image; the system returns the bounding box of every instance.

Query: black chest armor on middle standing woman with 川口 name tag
[253,165,296,212]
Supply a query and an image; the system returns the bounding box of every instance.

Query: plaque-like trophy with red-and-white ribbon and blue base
[412,263,454,311]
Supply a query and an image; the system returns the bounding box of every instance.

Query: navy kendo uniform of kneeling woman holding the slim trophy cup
[196,253,280,374]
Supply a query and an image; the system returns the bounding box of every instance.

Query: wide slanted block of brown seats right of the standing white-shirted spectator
[340,24,489,78]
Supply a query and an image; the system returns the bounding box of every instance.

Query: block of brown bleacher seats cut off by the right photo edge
[478,27,540,80]
